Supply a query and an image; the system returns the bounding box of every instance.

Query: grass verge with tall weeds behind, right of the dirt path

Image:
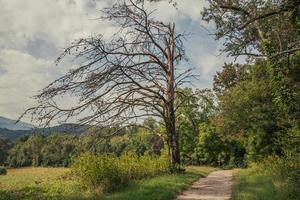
[234,154,300,200]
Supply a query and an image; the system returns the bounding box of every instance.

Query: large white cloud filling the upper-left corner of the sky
[0,0,112,48]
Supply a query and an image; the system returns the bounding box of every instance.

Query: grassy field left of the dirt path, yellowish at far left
[0,167,214,200]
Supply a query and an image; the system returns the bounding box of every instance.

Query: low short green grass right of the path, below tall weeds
[233,168,300,200]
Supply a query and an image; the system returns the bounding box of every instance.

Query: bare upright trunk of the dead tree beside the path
[166,24,180,171]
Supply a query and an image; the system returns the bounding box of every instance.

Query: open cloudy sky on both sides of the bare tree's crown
[0,0,230,122]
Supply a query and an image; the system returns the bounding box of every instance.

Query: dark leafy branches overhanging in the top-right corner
[202,0,300,60]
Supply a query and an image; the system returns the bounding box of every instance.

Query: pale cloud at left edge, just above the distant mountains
[0,50,56,118]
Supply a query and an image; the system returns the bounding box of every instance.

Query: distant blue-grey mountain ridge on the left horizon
[0,117,89,141]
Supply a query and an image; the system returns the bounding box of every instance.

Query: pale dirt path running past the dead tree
[176,170,232,200]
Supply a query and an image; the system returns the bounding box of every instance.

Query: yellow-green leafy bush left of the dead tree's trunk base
[72,153,169,191]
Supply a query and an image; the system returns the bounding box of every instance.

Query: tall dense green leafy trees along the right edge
[202,0,300,166]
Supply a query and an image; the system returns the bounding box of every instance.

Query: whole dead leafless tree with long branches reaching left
[22,0,193,169]
